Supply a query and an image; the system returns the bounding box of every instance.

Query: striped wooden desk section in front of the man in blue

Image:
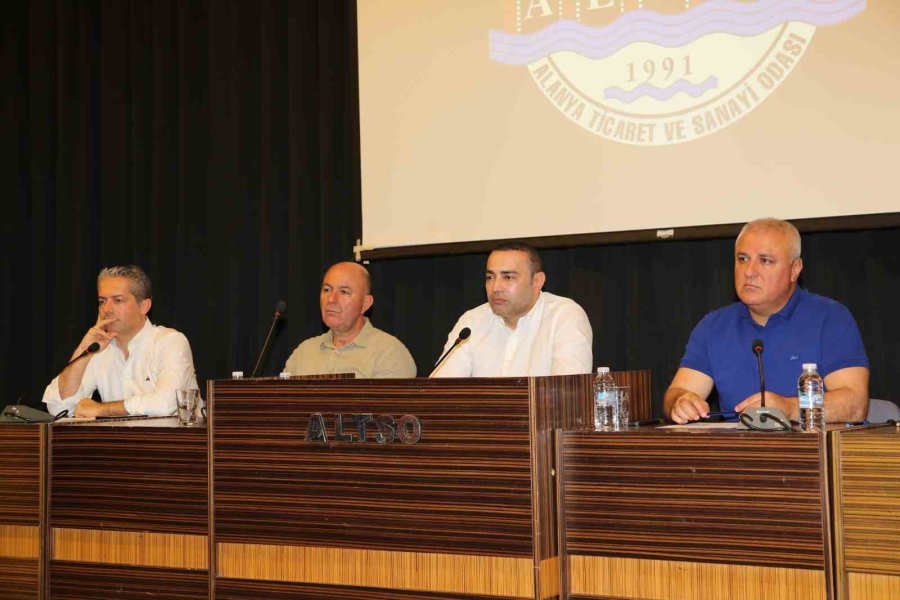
[557,429,833,600]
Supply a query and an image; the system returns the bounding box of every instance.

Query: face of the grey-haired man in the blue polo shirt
[734,229,803,319]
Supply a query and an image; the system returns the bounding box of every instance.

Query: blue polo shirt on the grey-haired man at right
[681,287,869,411]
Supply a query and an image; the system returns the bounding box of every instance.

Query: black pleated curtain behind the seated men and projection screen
[0,0,900,418]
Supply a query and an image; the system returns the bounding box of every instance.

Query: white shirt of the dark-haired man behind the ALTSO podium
[432,292,593,377]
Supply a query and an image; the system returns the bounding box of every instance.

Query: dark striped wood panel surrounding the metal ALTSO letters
[210,379,533,557]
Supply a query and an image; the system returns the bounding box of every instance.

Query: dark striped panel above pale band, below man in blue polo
[561,430,830,571]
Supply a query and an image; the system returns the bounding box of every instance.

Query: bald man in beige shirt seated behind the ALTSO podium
[284,262,416,379]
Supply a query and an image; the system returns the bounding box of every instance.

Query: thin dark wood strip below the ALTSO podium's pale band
[216,579,532,600]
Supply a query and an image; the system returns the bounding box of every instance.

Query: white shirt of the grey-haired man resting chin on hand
[44,319,198,417]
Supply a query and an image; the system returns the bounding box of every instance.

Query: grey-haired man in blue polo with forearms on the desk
[663,219,869,423]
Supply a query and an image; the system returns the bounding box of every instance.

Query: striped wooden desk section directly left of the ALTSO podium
[49,417,209,600]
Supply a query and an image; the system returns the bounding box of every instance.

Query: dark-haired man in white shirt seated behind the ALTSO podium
[432,242,593,377]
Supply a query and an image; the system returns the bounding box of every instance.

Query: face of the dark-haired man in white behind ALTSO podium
[484,250,545,327]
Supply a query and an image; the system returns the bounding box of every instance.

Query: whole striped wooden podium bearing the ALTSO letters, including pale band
[208,375,591,600]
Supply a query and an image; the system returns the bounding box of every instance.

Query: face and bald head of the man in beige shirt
[319,263,373,334]
